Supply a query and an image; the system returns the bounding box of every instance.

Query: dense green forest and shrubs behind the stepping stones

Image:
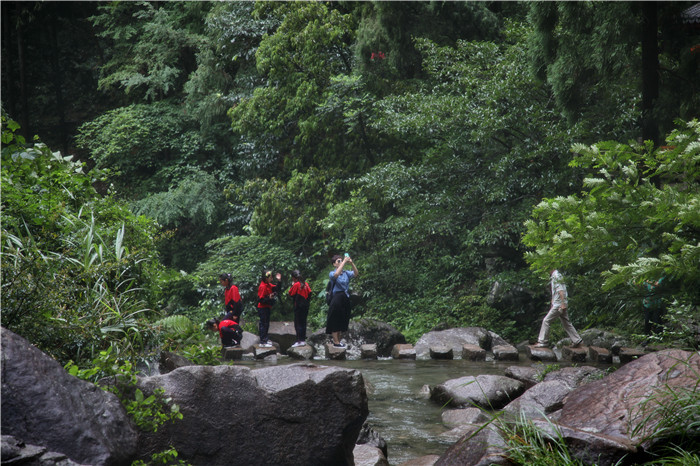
[1,1,700,364]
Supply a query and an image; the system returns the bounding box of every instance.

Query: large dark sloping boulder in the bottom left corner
[1,328,137,465]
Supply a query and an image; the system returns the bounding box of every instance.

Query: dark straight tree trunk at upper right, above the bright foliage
[641,2,659,145]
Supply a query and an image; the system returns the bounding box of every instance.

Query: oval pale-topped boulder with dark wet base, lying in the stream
[430,375,525,409]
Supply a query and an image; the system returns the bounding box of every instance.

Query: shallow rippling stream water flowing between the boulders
[246,355,584,465]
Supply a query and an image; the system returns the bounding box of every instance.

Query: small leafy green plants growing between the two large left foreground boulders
[65,346,182,432]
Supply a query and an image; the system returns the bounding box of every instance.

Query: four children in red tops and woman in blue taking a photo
[207,254,359,348]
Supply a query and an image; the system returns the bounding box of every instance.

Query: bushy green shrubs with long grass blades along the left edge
[0,116,160,362]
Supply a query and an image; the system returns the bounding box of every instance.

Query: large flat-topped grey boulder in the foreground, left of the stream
[133,363,368,465]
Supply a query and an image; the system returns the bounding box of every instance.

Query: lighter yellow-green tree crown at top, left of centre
[229,2,365,173]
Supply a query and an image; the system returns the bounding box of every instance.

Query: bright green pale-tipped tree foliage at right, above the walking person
[523,120,700,338]
